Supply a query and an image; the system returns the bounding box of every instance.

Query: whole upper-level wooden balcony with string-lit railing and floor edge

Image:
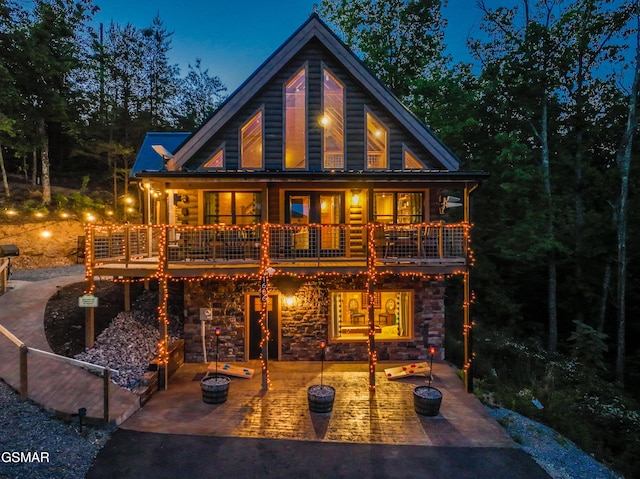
[86,223,469,277]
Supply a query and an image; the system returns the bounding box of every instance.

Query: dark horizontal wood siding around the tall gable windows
[185,40,437,174]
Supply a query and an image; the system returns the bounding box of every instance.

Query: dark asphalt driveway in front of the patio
[86,429,549,479]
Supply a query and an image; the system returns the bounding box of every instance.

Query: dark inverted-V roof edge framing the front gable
[169,13,460,170]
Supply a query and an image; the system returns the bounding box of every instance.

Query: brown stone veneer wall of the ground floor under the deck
[184,276,445,362]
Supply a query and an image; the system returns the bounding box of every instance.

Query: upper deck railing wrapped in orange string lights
[87,223,469,265]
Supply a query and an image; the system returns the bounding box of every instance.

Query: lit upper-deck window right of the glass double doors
[373,192,424,224]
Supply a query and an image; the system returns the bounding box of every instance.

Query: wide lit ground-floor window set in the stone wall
[329,291,413,341]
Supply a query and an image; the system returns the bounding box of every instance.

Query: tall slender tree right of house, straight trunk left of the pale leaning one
[474,0,562,351]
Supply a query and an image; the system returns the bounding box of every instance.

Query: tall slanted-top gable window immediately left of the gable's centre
[284,69,307,169]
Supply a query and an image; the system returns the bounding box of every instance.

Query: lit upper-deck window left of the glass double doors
[204,191,262,225]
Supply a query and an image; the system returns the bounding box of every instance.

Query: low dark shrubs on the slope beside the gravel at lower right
[474,334,640,477]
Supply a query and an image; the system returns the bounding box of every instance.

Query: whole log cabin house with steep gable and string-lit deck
[87,14,486,390]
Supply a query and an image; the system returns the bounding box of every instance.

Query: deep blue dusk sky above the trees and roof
[96,0,502,93]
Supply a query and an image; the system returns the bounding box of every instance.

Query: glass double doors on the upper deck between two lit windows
[285,191,345,258]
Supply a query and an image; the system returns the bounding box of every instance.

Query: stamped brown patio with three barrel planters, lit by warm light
[120,361,515,447]
